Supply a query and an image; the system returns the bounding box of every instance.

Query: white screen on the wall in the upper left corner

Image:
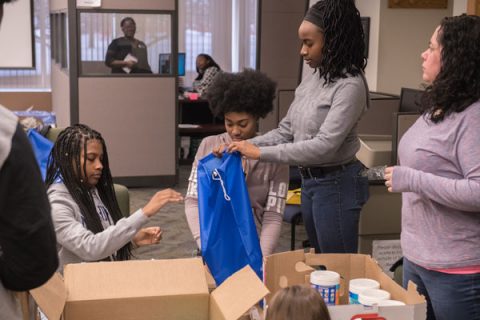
[0,0,35,69]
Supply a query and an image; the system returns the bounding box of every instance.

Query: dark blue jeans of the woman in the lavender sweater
[403,258,480,320]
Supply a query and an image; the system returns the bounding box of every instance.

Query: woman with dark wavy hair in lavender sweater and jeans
[385,15,480,320]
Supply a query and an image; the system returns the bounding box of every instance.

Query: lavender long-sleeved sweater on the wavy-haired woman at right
[392,102,480,269]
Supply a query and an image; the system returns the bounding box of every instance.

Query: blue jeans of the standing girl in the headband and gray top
[302,161,368,253]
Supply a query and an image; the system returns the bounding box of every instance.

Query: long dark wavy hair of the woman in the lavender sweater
[420,14,480,123]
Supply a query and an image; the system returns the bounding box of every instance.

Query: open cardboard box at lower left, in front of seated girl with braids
[31,258,268,320]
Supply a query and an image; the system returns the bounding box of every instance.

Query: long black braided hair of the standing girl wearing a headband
[304,0,367,83]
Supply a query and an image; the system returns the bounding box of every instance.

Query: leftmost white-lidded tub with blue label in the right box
[310,270,340,306]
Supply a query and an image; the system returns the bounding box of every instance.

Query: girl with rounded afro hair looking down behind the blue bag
[185,70,289,256]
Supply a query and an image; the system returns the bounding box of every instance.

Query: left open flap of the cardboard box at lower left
[30,273,67,320]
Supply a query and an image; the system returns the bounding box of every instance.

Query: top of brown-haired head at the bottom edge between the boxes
[266,285,330,320]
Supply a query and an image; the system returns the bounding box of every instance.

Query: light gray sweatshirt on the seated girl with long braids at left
[48,183,148,272]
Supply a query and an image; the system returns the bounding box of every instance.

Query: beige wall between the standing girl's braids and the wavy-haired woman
[356,0,452,94]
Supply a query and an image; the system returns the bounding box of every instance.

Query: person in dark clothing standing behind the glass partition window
[105,17,152,73]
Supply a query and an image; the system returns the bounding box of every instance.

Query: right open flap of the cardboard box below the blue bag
[210,265,269,320]
